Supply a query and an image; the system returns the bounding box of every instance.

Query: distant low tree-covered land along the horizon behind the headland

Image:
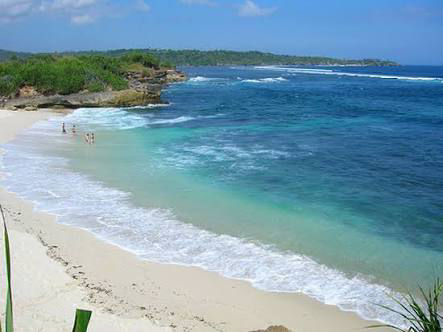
[0,48,398,66]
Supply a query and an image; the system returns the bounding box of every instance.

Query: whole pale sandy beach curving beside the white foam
[0,110,390,332]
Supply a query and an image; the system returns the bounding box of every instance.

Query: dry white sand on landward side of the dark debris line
[0,111,171,332]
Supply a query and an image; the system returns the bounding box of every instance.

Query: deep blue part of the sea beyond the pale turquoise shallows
[165,66,443,251]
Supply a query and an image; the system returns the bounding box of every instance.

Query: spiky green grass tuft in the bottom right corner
[369,279,443,332]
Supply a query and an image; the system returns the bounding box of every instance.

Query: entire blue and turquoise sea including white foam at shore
[0,66,443,324]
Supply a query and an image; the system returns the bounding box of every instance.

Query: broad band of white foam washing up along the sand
[0,119,410,325]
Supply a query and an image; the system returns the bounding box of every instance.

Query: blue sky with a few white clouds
[0,0,443,65]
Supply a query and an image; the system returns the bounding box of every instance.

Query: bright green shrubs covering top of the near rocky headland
[0,52,164,96]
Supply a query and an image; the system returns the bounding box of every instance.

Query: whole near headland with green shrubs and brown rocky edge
[0,53,186,110]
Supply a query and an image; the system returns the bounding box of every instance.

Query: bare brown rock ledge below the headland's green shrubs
[0,69,186,110]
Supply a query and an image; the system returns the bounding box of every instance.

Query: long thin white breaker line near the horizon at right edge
[254,66,443,83]
